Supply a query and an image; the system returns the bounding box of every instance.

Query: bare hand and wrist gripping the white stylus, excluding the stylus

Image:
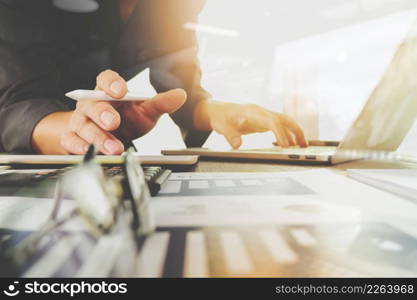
[32,70,186,154]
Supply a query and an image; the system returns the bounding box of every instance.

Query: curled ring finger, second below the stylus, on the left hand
[77,121,124,155]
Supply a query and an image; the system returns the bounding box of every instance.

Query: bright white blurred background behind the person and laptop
[129,0,417,154]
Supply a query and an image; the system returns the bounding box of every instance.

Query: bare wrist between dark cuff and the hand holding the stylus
[32,112,72,154]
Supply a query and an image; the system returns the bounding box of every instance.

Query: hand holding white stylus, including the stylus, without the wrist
[61,70,186,154]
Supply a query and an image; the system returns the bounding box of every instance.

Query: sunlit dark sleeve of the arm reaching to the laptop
[117,0,210,147]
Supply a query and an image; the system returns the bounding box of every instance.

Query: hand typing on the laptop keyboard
[194,101,308,149]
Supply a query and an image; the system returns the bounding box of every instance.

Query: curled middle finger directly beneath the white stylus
[77,101,121,131]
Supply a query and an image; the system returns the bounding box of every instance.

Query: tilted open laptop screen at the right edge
[340,17,417,151]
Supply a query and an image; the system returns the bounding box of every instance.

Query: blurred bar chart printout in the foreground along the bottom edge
[0,224,417,278]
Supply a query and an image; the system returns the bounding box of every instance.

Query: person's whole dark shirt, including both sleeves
[0,0,209,153]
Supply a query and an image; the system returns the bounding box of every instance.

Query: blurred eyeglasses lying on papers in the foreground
[5,145,155,265]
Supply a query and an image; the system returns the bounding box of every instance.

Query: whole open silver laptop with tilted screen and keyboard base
[162,18,417,164]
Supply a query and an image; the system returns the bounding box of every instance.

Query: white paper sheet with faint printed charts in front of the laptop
[151,170,417,226]
